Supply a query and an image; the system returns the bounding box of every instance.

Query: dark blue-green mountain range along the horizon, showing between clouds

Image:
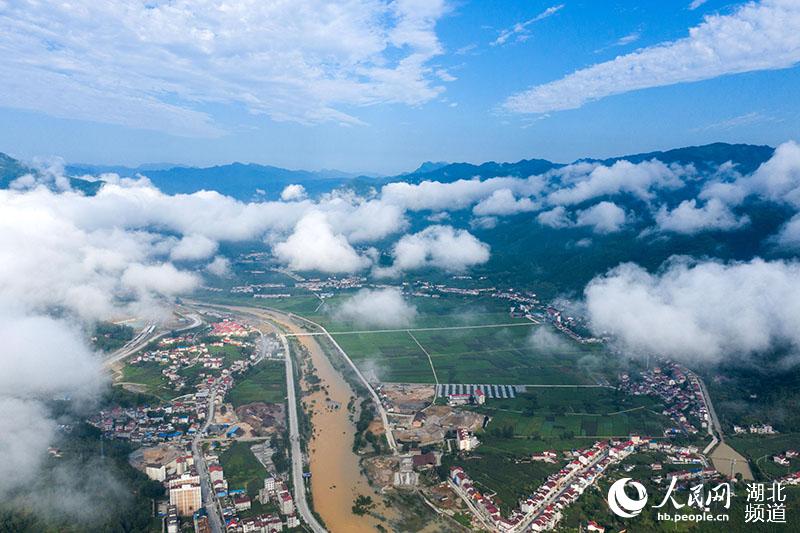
[0,143,793,295]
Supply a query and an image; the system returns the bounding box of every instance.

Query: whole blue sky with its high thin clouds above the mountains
[0,0,800,173]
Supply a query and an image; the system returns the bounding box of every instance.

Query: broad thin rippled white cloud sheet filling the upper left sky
[0,0,448,133]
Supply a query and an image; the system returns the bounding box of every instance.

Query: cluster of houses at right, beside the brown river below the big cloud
[620,361,710,435]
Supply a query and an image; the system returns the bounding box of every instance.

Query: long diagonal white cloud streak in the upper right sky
[503,0,800,113]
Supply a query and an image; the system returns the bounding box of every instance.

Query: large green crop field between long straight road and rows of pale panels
[334,322,611,385]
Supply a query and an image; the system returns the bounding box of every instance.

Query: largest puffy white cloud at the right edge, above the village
[585,258,800,362]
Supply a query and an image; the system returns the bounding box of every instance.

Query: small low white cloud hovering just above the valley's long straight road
[334,288,417,328]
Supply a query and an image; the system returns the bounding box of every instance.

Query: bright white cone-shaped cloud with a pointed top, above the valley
[274,211,371,273]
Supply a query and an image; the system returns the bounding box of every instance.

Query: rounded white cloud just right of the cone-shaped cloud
[376,226,489,275]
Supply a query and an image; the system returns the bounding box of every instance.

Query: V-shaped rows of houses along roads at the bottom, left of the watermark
[448,437,649,532]
